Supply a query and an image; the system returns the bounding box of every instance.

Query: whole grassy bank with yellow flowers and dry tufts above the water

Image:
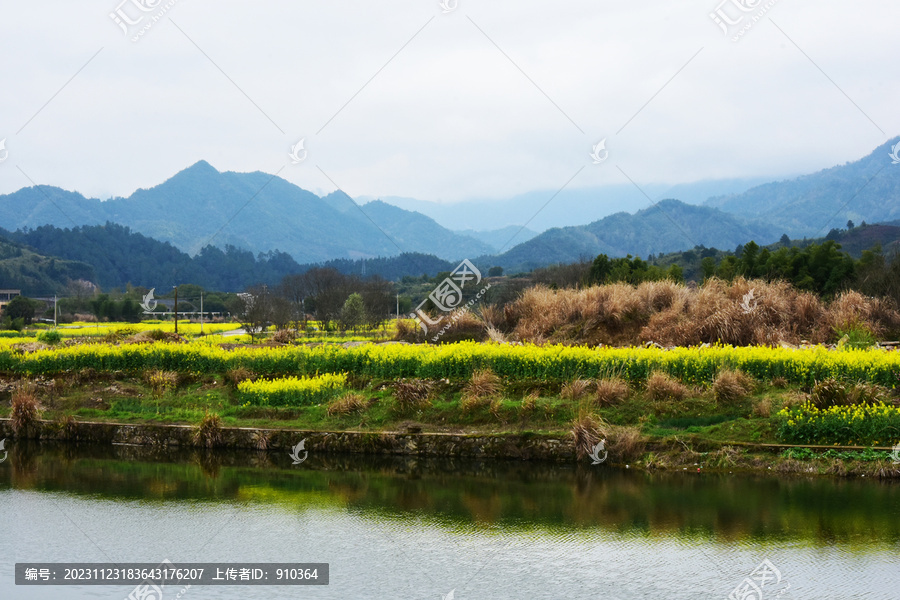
[0,342,900,476]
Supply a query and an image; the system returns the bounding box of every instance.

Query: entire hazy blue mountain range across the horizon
[0,138,900,285]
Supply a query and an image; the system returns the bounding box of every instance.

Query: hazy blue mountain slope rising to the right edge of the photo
[706,137,900,237]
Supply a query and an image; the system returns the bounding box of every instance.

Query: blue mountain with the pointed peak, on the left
[0,161,492,263]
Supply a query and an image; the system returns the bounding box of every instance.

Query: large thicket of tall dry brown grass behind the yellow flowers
[464,277,900,346]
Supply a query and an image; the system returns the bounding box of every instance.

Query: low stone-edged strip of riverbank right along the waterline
[0,419,900,479]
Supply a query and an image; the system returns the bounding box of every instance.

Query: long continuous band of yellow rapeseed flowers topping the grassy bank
[0,341,900,388]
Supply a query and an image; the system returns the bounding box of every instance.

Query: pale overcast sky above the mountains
[0,0,900,216]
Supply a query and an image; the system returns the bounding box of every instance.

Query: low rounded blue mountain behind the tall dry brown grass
[486,200,781,273]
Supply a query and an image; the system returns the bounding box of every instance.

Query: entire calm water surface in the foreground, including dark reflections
[0,443,900,600]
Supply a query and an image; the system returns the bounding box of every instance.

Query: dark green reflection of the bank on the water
[0,442,900,548]
